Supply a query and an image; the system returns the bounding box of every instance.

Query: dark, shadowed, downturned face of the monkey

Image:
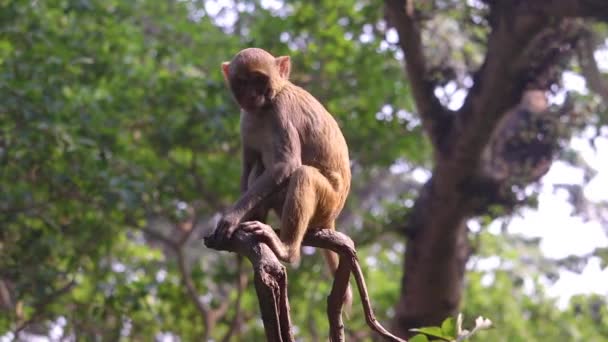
[230,72,271,111]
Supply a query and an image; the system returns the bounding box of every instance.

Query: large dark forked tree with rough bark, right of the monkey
[385,0,608,336]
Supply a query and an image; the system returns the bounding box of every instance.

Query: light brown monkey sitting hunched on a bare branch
[215,48,352,310]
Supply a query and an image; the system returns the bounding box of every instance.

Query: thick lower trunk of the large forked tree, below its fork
[393,179,469,337]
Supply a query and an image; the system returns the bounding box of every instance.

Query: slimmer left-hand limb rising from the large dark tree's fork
[385,0,448,144]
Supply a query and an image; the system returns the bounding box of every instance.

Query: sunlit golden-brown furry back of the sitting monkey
[274,83,351,199]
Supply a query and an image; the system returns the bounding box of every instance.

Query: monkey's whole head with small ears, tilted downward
[222,48,291,112]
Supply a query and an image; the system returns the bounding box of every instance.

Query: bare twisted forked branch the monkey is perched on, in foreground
[205,229,405,342]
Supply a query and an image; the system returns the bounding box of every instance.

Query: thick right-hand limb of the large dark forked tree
[446,10,575,174]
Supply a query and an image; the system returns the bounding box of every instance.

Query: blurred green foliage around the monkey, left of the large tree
[0,0,428,340]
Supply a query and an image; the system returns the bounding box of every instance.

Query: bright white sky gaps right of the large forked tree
[482,65,608,307]
